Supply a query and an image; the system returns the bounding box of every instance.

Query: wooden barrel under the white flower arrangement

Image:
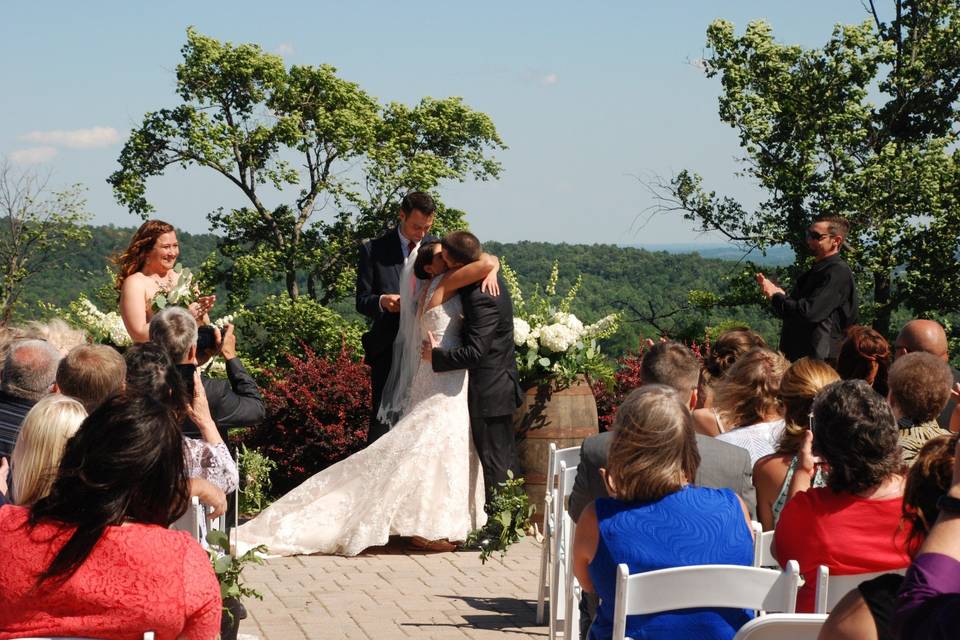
[513,381,599,523]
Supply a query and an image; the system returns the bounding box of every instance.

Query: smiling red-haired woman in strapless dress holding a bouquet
[114,220,216,342]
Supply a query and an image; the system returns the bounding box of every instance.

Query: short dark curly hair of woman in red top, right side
[811,380,903,493]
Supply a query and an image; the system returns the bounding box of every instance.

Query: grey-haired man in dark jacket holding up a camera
[149,307,266,440]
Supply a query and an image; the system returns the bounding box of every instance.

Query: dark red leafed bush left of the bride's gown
[242,345,371,495]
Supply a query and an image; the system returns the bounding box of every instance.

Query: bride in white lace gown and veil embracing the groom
[237,242,499,556]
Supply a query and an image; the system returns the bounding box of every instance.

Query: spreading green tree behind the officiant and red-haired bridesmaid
[108,28,504,304]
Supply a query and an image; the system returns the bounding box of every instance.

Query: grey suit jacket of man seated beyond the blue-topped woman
[570,431,757,521]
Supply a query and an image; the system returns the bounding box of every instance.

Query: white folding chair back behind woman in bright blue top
[613,560,800,640]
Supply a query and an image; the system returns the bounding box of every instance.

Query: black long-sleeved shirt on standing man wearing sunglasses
[770,254,858,362]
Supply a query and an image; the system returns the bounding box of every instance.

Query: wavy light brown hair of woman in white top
[714,349,790,429]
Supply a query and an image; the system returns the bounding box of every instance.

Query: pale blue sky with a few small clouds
[0,0,867,244]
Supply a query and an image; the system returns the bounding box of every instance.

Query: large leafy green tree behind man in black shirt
[659,0,960,333]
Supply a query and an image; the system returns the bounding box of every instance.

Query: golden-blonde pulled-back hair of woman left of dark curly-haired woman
[777,358,840,455]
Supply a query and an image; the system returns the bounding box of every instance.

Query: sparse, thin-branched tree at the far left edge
[0,159,91,325]
